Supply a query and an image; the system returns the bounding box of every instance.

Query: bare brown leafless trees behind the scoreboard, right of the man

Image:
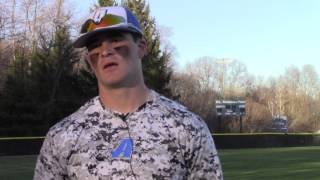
[169,57,320,133]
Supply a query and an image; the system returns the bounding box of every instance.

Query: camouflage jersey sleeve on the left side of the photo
[33,132,67,180]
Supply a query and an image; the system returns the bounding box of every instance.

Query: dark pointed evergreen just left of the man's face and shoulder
[34,26,96,127]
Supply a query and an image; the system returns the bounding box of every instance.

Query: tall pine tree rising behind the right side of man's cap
[123,0,172,97]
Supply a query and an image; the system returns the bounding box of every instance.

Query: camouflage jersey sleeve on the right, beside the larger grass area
[186,120,223,180]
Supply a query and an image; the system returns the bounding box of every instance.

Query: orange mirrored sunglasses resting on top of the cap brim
[80,14,126,33]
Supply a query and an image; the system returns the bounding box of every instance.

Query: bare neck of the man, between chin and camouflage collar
[99,84,149,113]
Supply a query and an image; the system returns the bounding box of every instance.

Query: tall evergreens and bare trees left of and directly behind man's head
[0,0,171,136]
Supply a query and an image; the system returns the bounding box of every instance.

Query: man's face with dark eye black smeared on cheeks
[87,32,146,88]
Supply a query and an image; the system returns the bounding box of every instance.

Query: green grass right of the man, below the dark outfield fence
[219,147,320,180]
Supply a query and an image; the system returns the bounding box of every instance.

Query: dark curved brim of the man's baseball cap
[73,26,142,48]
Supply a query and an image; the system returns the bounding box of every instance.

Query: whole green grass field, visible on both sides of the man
[0,146,320,180]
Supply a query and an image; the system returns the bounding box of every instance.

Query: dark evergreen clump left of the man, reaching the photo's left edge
[0,26,96,136]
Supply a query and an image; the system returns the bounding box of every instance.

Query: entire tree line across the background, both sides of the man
[0,0,320,136]
